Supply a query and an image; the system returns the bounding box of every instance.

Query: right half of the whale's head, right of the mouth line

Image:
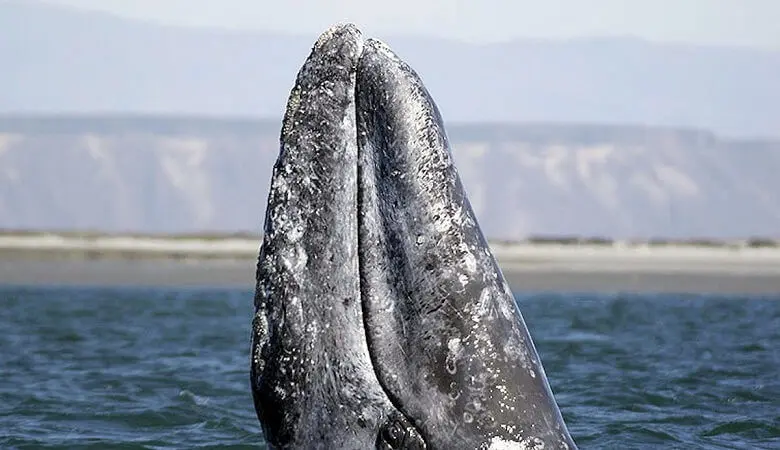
[356,40,574,449]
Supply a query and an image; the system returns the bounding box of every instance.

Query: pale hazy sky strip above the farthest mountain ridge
[47,0,780,48]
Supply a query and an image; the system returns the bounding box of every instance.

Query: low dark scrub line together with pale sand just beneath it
[0,230,780,264]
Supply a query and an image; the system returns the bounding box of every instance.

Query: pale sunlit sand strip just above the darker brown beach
[0,234,780,268]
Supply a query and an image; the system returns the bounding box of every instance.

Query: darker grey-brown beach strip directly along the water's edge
[0,260,780,299]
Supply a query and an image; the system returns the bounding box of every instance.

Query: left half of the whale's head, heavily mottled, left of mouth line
[251,26,420,449]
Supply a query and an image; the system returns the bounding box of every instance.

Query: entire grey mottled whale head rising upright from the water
[249,24,576,450]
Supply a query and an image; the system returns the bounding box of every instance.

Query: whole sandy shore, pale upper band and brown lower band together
[0,235,780,294]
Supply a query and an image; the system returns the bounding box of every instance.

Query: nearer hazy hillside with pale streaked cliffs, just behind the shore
[0,116,780,239]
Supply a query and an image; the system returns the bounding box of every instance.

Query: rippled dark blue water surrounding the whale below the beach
[0,287,780,449]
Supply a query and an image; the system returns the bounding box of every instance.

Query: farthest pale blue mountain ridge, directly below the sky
[0,0,780,138]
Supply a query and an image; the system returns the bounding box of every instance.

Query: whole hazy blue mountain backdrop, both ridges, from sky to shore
[0,0,780,238]
